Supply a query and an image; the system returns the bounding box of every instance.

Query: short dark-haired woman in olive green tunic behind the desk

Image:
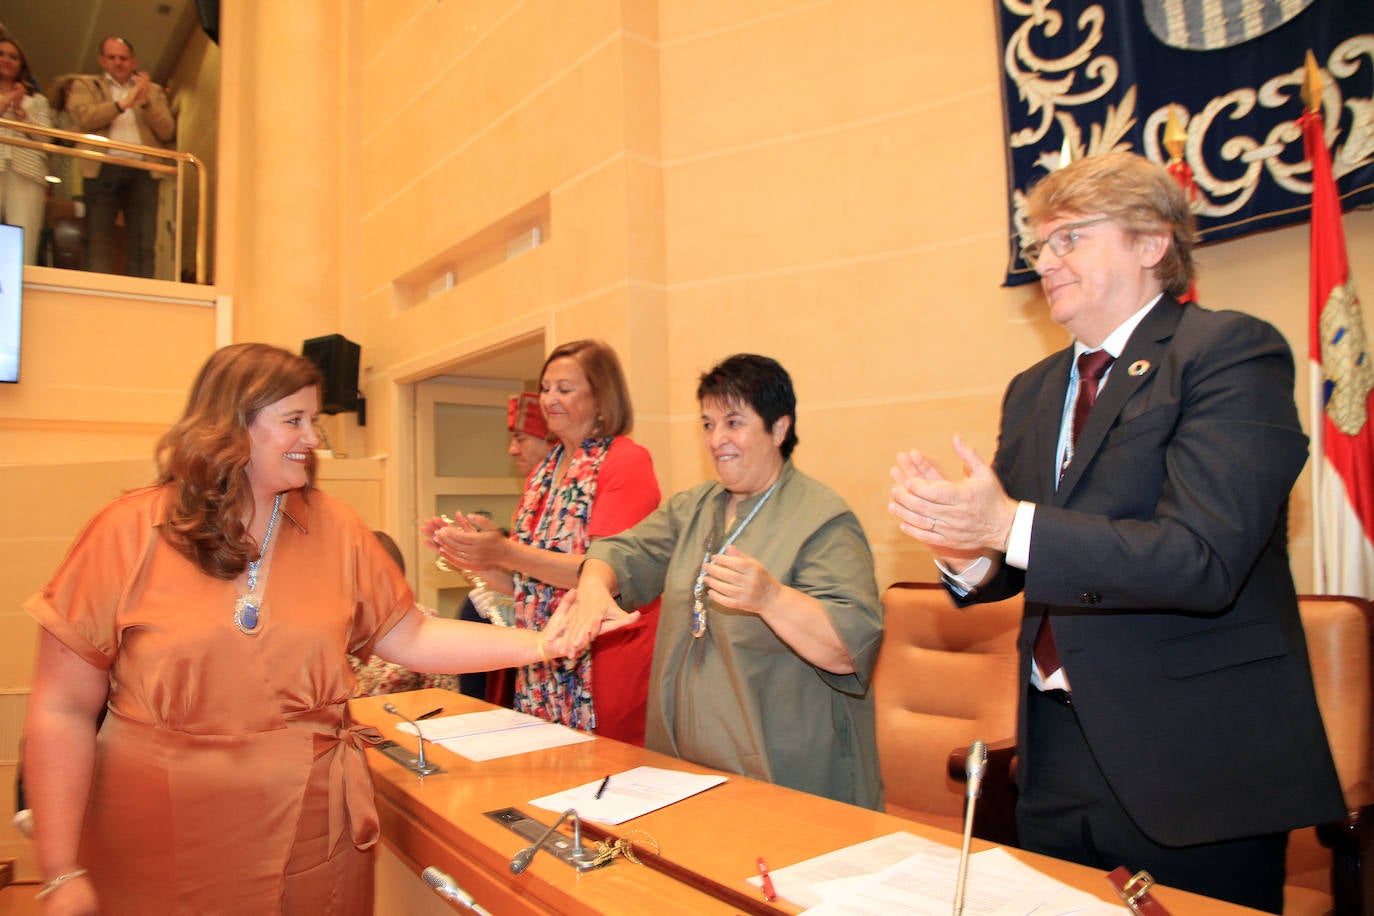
[569,354,882,809]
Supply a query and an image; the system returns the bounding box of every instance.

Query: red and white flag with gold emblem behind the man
[1301,103,1374,599]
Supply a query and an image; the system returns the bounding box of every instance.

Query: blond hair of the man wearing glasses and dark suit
[1025,152,1197,295]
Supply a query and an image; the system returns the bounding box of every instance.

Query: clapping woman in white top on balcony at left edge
[0,37,52,264]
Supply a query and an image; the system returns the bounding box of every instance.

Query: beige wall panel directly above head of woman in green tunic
[668,251,1033,411]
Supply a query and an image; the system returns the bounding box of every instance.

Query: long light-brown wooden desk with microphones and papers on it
[352,689,1253,916]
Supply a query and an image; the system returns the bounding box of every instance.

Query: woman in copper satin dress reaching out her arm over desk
[25,343,623,916]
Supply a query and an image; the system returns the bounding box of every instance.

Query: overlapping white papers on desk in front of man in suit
[750,832,1124,916]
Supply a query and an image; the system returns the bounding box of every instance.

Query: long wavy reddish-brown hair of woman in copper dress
[157,343,320,580]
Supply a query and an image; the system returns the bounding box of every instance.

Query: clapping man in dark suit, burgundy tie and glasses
[890,152,1345,912]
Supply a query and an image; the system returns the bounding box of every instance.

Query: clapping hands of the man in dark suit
[888,435,1017,562]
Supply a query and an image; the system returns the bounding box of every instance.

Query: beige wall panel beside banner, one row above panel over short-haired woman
[664,93,1004,286]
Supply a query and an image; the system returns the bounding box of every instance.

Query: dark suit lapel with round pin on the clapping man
[1055,294,1184,505]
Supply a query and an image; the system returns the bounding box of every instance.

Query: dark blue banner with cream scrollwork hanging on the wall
[995,0,1374,286]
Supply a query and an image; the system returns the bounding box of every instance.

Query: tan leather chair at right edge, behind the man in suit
[1287,595,1374,894]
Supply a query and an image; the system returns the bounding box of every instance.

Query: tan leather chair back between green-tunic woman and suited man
[872,582,1022,823]
